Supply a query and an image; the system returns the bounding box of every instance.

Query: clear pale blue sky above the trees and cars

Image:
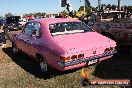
[0,0,132,16]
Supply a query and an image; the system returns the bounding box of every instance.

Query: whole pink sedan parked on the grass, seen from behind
[13,18,117,73]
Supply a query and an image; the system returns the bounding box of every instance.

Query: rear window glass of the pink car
[49,22,92,36]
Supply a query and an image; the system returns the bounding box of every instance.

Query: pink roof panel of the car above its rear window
[31,18,80,24]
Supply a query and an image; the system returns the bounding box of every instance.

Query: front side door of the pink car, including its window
[17,23,33,54]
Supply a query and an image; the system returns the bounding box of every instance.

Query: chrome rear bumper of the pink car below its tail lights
[58,51,117,67]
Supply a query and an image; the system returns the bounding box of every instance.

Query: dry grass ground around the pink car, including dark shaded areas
[0,39,132,88]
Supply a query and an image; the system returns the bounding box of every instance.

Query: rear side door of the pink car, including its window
[27,22,41,58]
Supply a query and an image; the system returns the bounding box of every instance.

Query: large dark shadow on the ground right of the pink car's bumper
[94,46,132,80]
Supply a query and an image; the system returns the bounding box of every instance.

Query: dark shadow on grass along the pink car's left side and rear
[3,47,80,79]
